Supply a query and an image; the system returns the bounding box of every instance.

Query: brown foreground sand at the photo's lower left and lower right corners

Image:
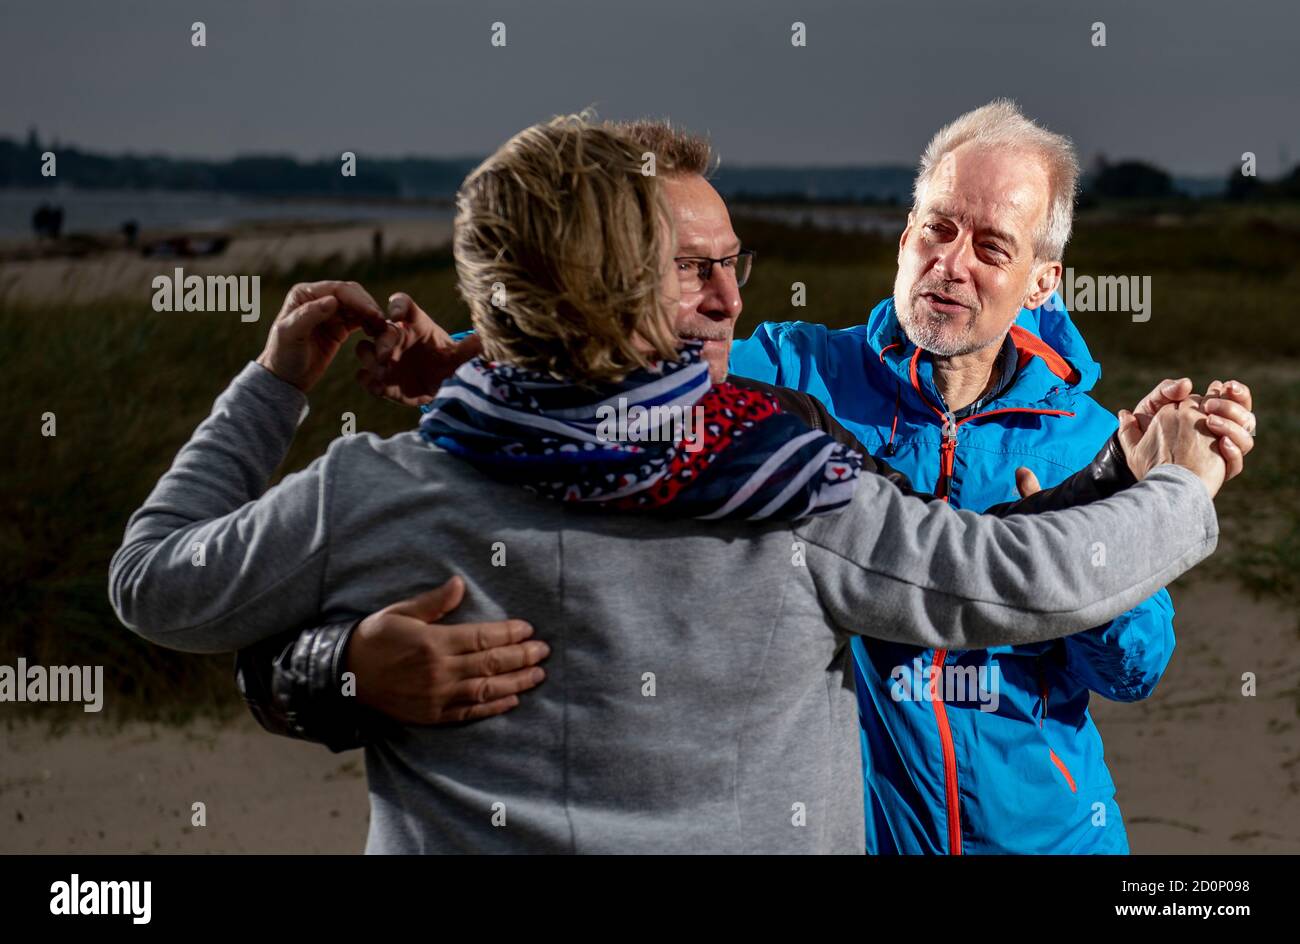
[0,581,1300,853]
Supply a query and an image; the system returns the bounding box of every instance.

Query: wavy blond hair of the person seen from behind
[452,113,677,385]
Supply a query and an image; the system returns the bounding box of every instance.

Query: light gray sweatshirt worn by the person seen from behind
[109,364,1218,853]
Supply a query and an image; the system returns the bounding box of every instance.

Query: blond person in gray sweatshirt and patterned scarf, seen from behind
[109,112,1225,854]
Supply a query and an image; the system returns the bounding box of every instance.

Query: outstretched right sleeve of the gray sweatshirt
[793,465,1218,649]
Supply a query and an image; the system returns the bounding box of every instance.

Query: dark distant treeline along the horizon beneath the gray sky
[0,131,1300,205]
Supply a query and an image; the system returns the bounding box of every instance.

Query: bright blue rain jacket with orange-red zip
[731,298,1174,854]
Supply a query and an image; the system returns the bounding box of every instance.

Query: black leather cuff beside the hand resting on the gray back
[235,620,373,752]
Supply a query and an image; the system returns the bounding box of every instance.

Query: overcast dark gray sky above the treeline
[0,0,1300,176]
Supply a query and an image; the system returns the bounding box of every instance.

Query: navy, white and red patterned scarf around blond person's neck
[420,342,862,520]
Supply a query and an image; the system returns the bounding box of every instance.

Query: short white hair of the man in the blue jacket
[911,99,1079,260]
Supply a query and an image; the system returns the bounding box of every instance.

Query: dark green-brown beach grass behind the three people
[0,208,1300,722]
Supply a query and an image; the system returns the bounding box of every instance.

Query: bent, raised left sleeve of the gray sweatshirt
[109,363,333,653]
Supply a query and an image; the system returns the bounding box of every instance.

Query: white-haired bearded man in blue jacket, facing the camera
[731,100,1255,854]
